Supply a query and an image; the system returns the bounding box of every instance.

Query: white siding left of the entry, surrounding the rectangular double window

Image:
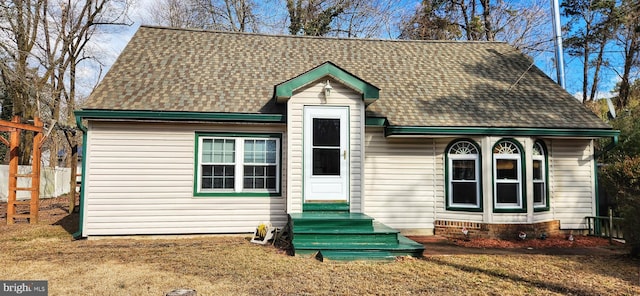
[83,121,287,236]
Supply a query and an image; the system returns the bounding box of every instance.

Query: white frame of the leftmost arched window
[447,140,482,209]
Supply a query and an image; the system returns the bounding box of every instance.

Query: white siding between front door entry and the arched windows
[364,128,444,230]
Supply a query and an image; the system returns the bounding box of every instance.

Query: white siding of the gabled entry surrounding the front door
[283,78,364,213]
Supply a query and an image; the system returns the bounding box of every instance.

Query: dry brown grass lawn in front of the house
[0,197,640,295]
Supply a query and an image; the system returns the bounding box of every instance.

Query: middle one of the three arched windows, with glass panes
[493,140,524,210]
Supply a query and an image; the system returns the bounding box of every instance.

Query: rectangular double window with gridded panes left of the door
[194,134,281,196]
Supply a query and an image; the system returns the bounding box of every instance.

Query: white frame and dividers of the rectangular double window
[194,133,282,196]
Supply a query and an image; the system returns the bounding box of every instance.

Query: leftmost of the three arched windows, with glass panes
[446,140,482,211]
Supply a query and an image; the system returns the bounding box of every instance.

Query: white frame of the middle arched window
[492,140,524,209]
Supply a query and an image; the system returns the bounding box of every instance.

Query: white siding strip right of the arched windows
[547,139,596,229]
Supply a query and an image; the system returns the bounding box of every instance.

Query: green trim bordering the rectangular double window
[193,132,282,197]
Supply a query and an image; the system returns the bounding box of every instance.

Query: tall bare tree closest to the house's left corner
[40,0,129,211]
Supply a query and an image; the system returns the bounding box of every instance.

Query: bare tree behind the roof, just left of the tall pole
[400,0,551,54]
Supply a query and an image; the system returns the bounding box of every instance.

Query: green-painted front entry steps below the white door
[289,212,424,260]
